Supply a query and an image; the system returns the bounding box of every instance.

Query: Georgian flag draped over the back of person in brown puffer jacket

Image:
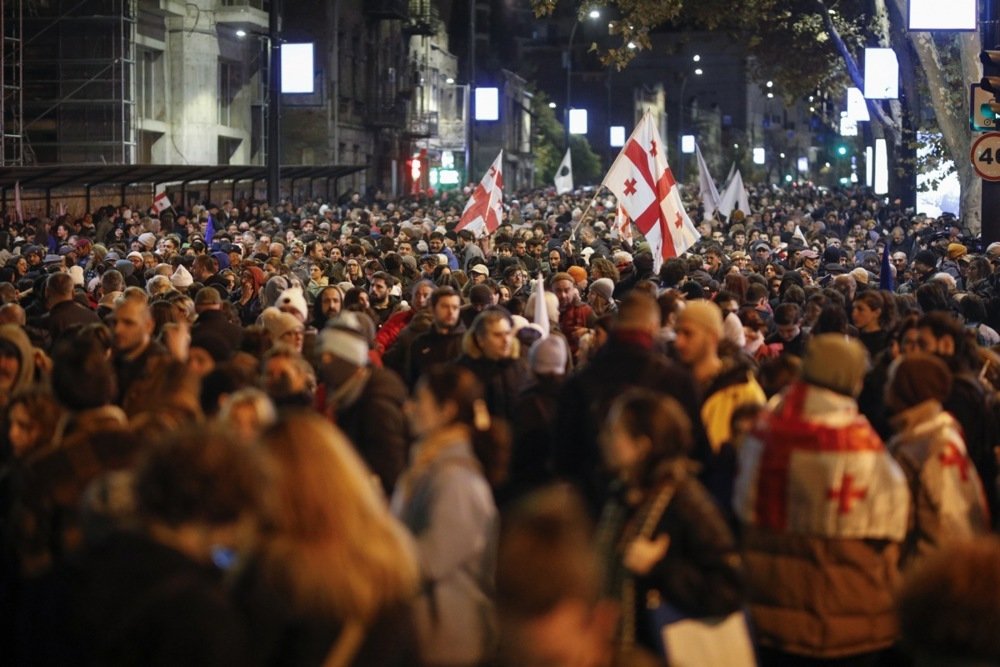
[733,383,910,542]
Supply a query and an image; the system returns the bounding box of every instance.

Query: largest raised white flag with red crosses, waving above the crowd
[602,112,701,272]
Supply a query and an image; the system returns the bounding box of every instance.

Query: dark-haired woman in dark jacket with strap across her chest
[600,389,752,664]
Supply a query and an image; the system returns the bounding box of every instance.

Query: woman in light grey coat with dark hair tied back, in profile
[392,366,499,666]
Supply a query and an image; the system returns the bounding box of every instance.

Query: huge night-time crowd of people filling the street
[0,180,1000,667]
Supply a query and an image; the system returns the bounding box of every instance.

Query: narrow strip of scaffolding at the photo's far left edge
[0,0,24,167]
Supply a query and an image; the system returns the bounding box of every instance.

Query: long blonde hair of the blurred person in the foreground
[262,410,419,622]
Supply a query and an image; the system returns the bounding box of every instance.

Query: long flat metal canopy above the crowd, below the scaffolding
[0,164,366,190]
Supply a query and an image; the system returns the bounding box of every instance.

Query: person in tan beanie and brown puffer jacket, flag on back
[733,334,910,665]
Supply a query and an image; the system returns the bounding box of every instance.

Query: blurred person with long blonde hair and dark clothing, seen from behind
[235,409,420,667]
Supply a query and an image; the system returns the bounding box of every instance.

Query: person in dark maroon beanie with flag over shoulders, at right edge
[886,353,989,567]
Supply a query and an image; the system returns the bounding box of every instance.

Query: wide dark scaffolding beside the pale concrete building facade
[21,0,137,165]
